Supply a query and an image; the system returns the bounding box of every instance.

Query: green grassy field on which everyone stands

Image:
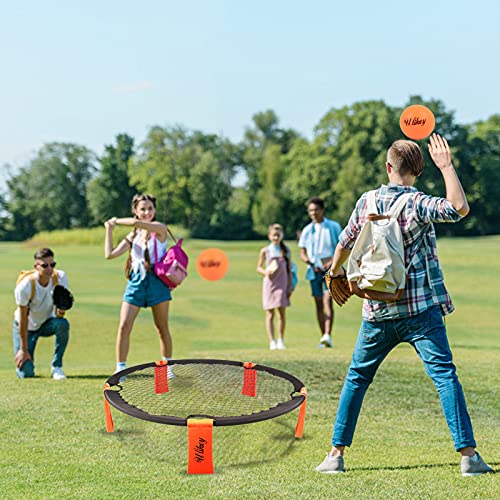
[0,237,500,499]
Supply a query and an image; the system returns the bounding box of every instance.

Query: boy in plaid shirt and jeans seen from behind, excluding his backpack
[316,134,492,476]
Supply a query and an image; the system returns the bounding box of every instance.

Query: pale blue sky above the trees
[0,0,500,186]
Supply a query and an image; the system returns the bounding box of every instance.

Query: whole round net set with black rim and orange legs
[104,359,307,474]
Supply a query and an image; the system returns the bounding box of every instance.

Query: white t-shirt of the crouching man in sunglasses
[14,269,68,330]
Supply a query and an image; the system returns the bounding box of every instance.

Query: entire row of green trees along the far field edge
[0,96,500,240]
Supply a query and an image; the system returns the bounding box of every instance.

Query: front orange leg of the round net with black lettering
[188,418,214,474]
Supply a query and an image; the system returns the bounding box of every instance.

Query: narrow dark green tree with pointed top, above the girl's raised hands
[87,134,136,223]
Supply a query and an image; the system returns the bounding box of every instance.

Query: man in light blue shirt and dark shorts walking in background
[299,197,342,347]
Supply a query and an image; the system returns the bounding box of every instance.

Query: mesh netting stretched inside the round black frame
[108,362,303,425]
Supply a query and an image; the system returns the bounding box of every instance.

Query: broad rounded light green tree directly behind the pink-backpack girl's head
[129,127,239,234]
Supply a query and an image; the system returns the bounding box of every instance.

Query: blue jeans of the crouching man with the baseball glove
[12,318,69,378]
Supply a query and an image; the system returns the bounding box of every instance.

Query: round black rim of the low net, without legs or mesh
[104,359,306,426]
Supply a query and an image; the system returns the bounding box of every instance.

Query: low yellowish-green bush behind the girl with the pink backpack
[25,225,189,247]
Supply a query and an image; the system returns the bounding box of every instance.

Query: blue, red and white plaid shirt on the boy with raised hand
[339,183,462,321]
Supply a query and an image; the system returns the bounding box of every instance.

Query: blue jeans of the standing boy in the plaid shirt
[332,306,476,451]
